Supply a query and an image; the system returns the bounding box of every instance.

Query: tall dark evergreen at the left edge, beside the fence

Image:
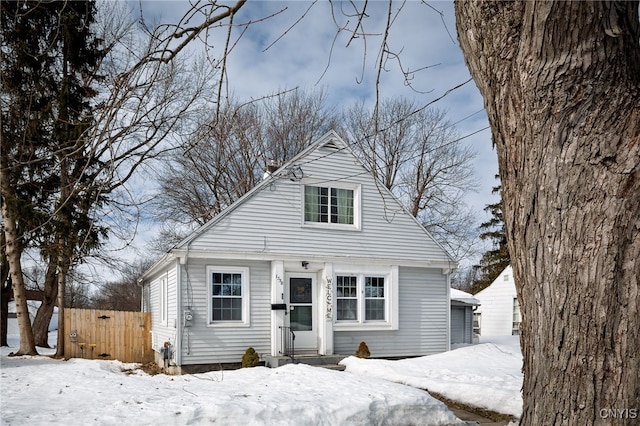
[1,1,104,353]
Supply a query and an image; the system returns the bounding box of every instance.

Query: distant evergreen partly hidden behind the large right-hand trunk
[470,176,511,294]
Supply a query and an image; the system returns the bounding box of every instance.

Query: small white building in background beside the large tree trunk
[475,266,522,336]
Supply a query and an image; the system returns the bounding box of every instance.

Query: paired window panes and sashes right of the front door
[335,274,390,323]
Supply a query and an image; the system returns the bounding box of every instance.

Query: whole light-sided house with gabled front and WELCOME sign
[143,131,456,372]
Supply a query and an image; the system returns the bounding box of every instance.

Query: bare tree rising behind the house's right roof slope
[345,99,475,259]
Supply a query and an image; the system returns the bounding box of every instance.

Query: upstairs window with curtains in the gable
[304,185,355,225]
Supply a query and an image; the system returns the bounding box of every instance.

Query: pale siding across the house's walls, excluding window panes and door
[148,134,455,365]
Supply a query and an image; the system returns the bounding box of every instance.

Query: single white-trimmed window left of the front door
[207,266,249,326]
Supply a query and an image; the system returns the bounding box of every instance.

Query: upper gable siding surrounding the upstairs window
[189,143,451,262]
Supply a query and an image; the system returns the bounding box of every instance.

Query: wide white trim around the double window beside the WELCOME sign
[333,266,399,331]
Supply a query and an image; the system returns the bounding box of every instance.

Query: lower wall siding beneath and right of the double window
[334,267,450,357]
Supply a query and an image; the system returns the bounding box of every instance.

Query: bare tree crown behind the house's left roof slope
[155,90,336,246]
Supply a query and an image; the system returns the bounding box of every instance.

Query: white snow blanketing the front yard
[0,336,522,426]
